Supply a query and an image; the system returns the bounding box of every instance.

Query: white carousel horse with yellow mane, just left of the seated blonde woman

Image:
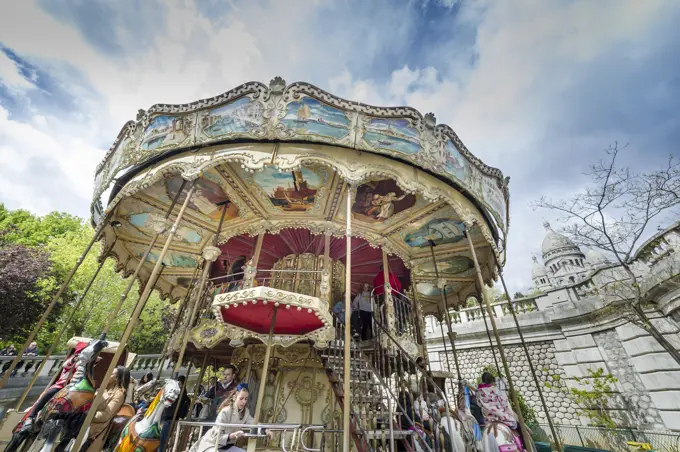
[115,380,182,452]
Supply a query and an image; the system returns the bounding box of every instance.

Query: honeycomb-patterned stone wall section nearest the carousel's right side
[439,341,580,425]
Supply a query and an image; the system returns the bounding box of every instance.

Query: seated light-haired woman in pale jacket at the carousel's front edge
[191,383,253,452]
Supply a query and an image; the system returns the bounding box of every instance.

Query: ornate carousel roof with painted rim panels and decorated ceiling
[92,78,509,316]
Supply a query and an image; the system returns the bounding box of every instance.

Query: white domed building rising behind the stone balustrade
[531,221,609,291]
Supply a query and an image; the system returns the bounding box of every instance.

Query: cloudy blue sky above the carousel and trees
[0,0,680,292]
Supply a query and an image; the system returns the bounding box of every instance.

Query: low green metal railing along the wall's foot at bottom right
[530,424,680,452]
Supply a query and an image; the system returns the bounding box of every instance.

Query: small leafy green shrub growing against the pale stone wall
[545,368,618,428]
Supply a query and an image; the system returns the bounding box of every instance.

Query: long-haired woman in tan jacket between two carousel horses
[81,366,130,452]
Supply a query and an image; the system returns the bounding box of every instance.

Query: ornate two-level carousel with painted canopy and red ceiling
[0,77,556,452]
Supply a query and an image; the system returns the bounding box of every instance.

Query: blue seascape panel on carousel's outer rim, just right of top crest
[281,97,351,140]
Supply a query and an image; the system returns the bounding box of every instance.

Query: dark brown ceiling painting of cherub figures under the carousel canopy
[352,179,416,223]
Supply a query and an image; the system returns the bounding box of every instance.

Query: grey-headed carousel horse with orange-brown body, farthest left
[29,334,108,452]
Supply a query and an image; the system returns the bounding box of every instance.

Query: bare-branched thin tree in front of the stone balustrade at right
[533,143,680,364]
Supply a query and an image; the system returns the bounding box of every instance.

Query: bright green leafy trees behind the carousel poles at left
[0,204,172,353]
